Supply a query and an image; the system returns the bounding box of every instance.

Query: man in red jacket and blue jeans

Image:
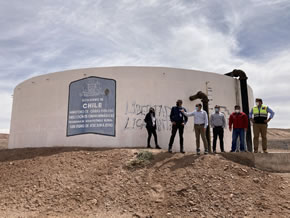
[229,105,248,152]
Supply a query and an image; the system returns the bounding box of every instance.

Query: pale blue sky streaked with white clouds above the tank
[0,0,290,132]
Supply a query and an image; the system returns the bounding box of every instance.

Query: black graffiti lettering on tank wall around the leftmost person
[124,102,171,131]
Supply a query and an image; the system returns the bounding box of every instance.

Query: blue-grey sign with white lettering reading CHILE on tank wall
[67,77,116,136]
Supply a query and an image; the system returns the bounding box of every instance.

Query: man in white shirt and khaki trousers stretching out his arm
[182,104,208,155]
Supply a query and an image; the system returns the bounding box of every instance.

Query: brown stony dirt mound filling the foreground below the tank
[0,148,290,217]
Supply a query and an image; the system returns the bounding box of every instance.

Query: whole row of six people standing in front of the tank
[144,98,274,155]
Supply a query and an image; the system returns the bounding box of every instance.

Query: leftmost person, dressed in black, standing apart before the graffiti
[144,107,161,149]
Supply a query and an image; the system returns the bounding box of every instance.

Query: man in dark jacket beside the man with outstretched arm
[168,100,188,153]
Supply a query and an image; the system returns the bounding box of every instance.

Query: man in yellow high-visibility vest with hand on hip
[249,98,275,153]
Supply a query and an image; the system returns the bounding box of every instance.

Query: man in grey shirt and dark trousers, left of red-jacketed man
[210,105,226,153]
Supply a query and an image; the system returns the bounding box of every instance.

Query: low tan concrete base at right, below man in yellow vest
[222,152,290,173]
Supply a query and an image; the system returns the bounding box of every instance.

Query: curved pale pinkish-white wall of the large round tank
[9,67,253,151]
